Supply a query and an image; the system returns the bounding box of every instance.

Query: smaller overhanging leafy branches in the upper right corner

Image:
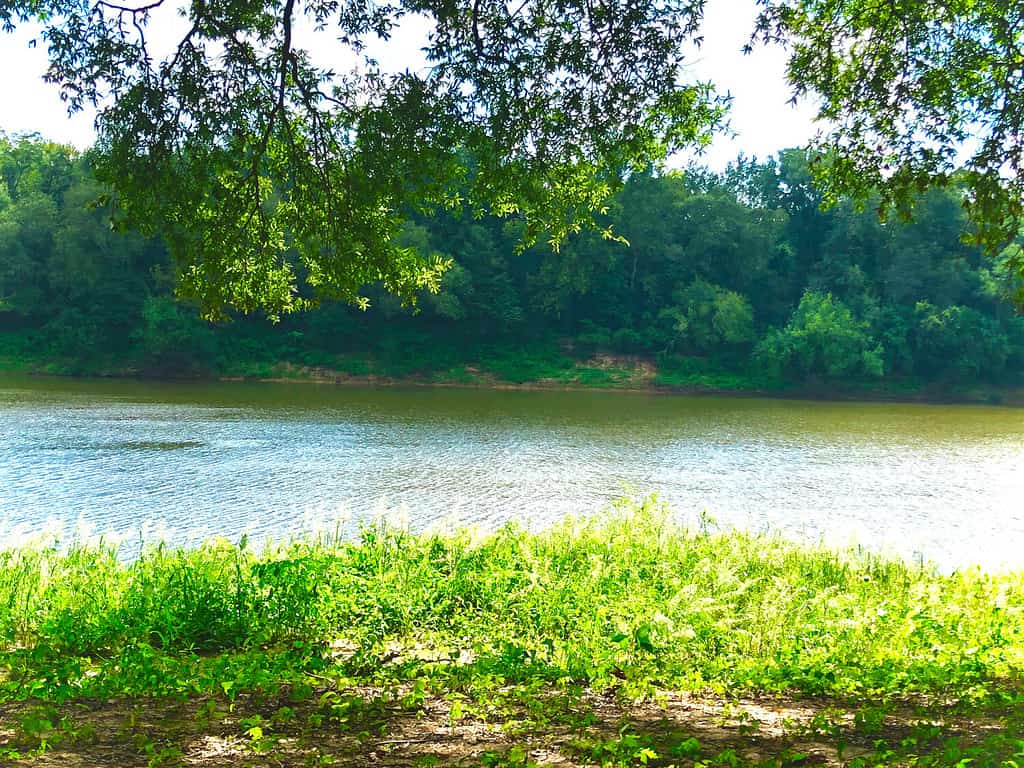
[756,0,1024,259]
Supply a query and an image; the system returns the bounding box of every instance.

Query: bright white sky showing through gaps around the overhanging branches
[0,0,816,170]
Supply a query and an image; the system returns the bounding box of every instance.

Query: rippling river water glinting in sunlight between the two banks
[0,377,1024,567]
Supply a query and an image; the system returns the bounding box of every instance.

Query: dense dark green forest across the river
[0,136,1024,388]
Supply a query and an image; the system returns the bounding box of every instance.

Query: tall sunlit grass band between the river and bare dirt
[0,499,1024,698]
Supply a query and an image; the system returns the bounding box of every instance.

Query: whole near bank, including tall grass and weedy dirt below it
[0,499,1024,768]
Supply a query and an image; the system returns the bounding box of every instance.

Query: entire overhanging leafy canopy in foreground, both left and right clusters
[0,0,1024,314]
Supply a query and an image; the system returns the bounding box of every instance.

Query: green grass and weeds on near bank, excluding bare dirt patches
[0,499,1024,768]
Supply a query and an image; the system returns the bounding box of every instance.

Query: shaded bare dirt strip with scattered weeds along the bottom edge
[0,691,999,768]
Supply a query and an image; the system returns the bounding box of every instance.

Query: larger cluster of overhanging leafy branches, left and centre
[0,0,723,315]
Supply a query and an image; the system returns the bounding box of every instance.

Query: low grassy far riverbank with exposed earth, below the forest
[0,354,1024,408]
